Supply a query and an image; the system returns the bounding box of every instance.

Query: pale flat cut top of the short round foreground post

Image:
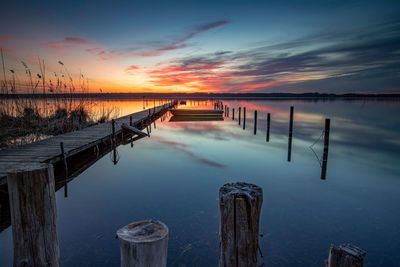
[117,220,168,243]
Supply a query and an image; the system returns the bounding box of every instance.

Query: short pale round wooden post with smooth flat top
[117,220,168,267]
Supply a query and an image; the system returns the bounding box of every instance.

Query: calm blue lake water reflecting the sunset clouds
[0,100,400,266]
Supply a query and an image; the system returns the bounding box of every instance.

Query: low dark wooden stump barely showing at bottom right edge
[324,244,367,267]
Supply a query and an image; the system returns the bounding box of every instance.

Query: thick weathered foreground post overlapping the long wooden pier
[7,163,60,267]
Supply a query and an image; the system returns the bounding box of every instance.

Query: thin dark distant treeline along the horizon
[0,93,400,99]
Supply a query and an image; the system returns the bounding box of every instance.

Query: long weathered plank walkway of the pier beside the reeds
[0,101,176,185]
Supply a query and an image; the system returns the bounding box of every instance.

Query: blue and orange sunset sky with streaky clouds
[0,0,400,93]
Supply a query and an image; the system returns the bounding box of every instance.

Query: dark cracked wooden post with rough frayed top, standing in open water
[219,183,263,267]
